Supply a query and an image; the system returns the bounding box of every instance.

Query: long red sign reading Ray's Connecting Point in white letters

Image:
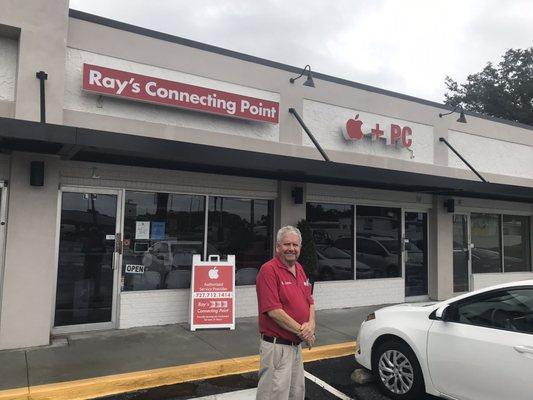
[83,64,279,124]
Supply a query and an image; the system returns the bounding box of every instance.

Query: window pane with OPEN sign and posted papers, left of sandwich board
[122,191,205,291]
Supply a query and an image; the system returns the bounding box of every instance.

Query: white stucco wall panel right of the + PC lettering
[448,130,533,178]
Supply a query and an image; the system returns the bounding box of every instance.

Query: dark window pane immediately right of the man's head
[307,203,353,281]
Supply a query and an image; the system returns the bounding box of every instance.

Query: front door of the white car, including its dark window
[427,286,533,400]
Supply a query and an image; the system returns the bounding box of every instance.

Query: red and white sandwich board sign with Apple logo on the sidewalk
[189,254,235,331]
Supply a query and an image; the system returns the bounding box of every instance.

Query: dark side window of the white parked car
[451,288,533,334]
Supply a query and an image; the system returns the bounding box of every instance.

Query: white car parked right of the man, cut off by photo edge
[355,280,533,400]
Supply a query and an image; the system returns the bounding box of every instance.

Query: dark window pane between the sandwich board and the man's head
[207,196,273,285]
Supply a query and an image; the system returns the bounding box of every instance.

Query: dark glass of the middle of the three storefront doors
[404,212,428,297]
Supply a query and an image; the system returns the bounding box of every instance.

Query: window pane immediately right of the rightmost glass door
[470,213,502,274]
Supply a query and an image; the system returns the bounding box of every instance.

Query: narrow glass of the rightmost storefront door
[453,214,470,293]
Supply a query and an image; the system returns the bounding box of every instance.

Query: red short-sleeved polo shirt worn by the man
[256,257,314,342]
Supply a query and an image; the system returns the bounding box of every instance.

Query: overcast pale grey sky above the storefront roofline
[70,0,533,102]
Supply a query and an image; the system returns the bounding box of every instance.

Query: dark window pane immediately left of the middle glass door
[355,206,401,279]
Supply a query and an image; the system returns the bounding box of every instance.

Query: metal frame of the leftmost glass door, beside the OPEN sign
[51,186,124,334]
